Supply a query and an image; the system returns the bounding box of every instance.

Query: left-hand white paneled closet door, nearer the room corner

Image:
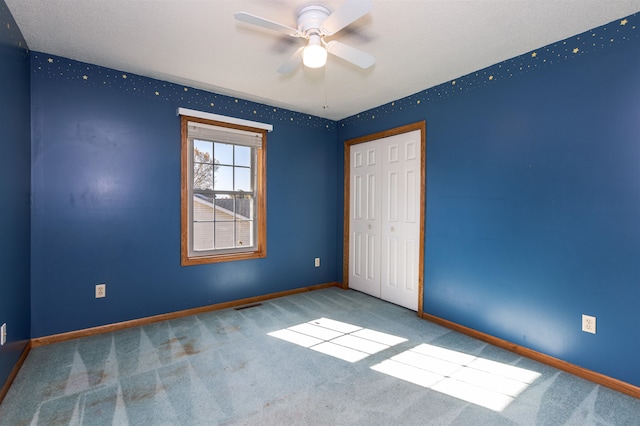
[349,142,381,297]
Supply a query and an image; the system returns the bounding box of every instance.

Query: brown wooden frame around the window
[180,115,267,266]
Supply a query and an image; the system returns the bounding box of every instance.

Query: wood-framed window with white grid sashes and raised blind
[181,115,266,265]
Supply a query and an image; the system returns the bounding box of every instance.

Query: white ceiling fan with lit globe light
[234,0,376,74]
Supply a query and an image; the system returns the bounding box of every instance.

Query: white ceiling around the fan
[5,0,640,120]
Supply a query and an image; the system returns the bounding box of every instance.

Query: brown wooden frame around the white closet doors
[342,121,427,318]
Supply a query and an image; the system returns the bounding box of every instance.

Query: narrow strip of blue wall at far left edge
[0,0,31,387]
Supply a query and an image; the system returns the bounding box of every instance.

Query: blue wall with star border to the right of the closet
[338,15,640,386]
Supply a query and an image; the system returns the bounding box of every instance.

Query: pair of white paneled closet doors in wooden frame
[349,130,421,311]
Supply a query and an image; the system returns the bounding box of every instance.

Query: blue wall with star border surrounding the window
[31,52,338,337]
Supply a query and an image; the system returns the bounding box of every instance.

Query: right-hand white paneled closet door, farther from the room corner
[380,131,420,311]
